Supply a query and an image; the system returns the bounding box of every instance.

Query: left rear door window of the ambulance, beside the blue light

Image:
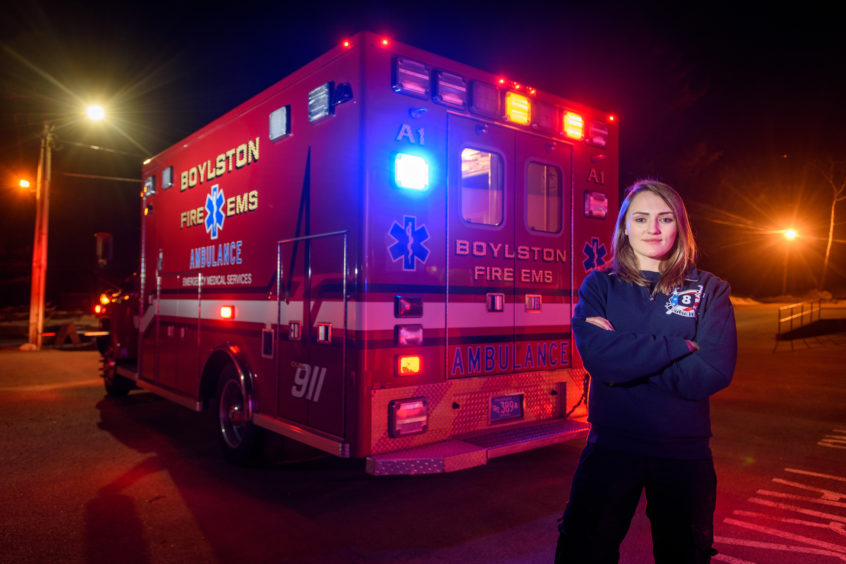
[461,148,504,225]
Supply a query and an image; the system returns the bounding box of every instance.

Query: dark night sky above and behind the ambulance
[0,1,846,306]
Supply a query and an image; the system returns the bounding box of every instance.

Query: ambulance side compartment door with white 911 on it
[277,233,347,437]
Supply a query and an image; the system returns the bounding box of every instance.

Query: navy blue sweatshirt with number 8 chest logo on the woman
[573,269,737,459]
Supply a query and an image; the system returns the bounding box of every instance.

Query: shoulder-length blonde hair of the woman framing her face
[611,180,696,294]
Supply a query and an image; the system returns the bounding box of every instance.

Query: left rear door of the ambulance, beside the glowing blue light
[446,115,516,378]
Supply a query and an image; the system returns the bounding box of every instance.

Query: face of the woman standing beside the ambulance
[626,190,678,272]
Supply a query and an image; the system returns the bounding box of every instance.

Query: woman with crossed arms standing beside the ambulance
[556,180,737,564]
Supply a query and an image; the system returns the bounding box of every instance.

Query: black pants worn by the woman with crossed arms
[555,444,717,564]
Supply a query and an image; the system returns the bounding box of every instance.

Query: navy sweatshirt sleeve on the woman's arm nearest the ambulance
[573,272,690,386]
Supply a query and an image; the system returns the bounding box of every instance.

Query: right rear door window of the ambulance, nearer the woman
[526,162,564,233]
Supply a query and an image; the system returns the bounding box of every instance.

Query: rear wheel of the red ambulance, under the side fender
[217,364,261,465]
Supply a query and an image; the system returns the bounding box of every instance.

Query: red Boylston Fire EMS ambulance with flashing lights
[100,29,619,475]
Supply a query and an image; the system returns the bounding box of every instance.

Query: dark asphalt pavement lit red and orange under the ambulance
[0,302,846,564]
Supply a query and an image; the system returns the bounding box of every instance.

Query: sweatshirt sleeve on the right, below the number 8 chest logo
[649,280,737,400]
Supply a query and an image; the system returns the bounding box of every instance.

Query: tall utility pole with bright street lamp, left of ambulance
[21,106,106,351]
